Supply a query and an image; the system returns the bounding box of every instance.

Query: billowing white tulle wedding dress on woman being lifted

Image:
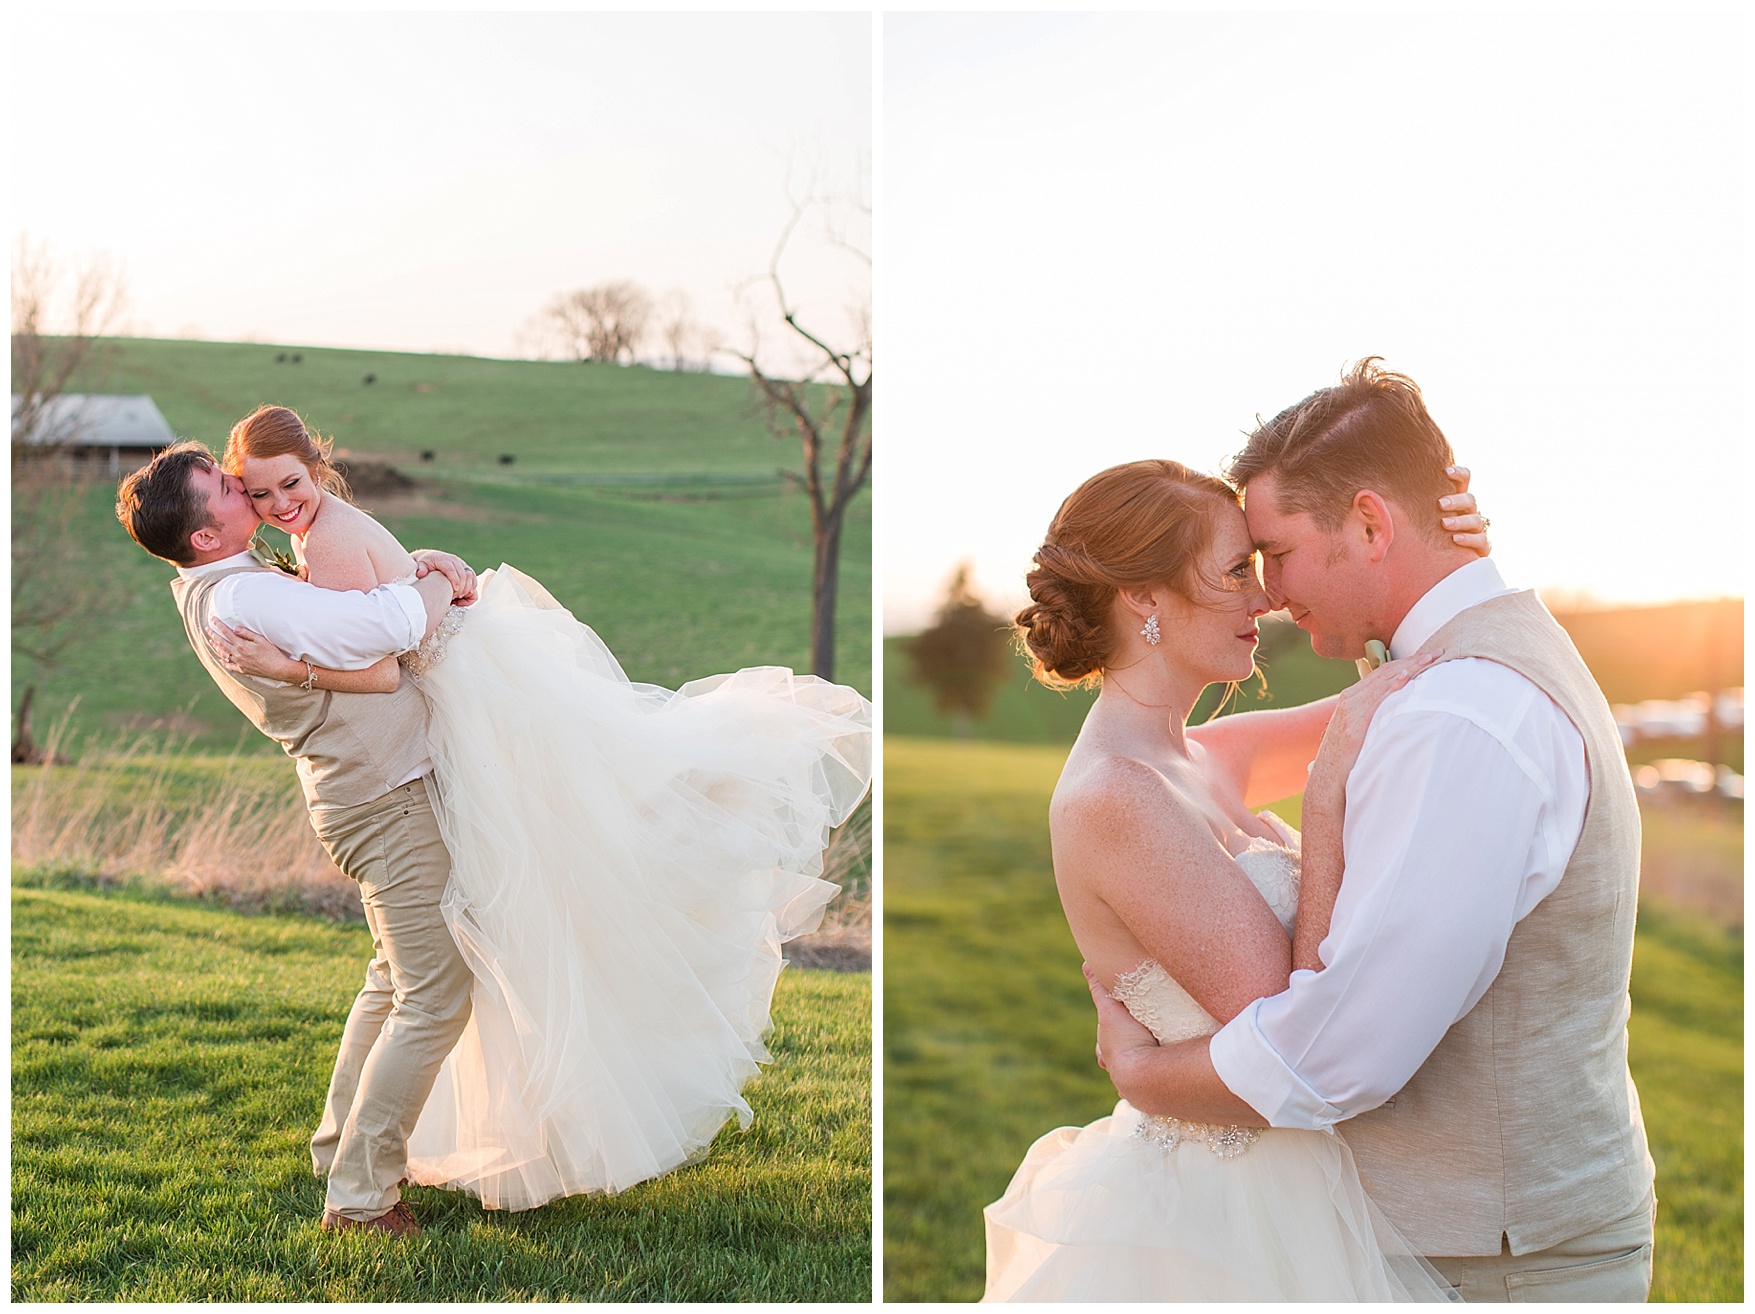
[391,565,872,1209]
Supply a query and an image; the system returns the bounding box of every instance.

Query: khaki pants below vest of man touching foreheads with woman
[1432,1200,1657,1303]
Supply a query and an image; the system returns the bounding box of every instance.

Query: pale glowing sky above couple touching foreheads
[878,12,1748,632]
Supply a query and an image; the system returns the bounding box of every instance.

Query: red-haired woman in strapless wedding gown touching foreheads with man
[983,461,1485,1302]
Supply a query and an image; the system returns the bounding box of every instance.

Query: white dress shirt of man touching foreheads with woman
[1211,560,1590,1128]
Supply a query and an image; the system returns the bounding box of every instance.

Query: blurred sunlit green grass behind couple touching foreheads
[883,737,1743,1300]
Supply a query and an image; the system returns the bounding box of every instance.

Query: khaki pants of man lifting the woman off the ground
[311,779,472,1219]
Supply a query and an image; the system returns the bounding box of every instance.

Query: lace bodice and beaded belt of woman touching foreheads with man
[1111,812,1299,1158]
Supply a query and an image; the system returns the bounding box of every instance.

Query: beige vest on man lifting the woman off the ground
[170,567,426,809]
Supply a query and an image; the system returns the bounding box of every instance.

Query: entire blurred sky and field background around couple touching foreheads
[881,14,1746,1300]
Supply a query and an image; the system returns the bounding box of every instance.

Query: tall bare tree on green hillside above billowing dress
[732,189,872,679]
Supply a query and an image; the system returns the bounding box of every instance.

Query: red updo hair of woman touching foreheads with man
[1016,461,1237,689]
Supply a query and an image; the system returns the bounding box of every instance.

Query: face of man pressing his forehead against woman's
[1243,474,1372,658]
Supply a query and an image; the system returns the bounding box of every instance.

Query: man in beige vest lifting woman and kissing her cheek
[116,442,474,1235]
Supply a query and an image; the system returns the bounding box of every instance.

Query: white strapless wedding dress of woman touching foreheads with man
[983,812,1458,1302]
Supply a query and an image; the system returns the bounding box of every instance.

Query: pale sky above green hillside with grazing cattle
[7,12,872,371]
